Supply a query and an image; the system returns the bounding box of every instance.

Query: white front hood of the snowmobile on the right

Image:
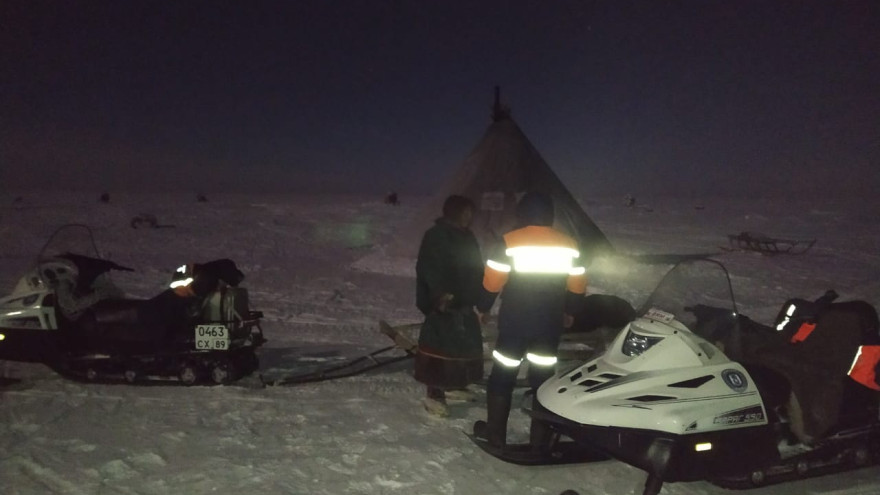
[537,312,767,434]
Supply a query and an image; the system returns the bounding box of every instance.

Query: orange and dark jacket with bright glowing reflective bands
[477,225,587,326]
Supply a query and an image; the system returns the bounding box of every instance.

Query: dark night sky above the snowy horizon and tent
[0,0,880,196]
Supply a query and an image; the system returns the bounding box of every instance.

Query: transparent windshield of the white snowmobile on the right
[638,259,737,338]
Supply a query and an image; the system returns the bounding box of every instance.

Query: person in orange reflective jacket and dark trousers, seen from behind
[474,193,587,449]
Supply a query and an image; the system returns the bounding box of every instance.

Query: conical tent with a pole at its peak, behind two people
[392,98,614,263]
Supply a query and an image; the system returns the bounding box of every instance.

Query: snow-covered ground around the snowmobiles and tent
[0,192,880,495]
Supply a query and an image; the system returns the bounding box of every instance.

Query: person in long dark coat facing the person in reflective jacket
[415,195,483,416]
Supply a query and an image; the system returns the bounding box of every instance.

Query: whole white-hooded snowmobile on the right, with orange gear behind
[527,260,880,495]
